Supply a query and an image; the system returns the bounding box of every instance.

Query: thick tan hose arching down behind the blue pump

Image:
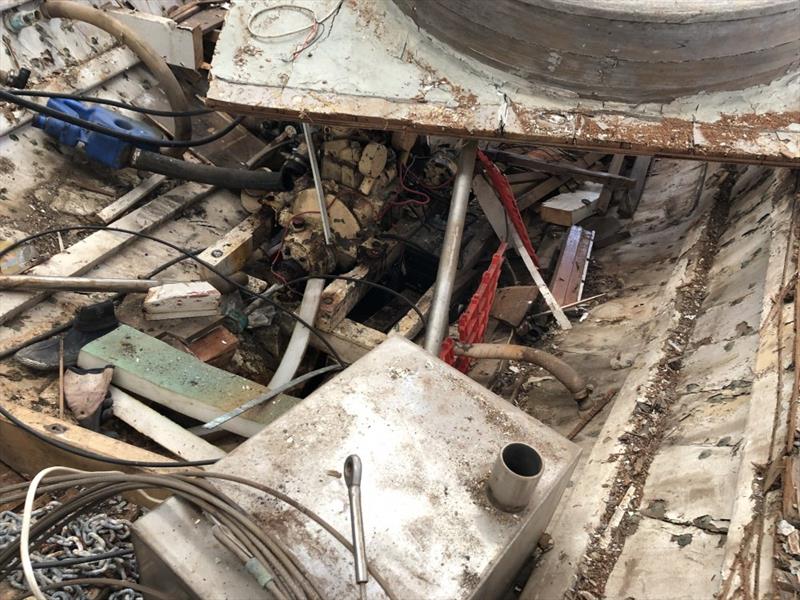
[39,0,192,154]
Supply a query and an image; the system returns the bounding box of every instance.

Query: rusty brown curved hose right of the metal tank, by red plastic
[454,344,591,408]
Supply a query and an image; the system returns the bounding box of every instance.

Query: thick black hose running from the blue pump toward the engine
[130,149,294,192]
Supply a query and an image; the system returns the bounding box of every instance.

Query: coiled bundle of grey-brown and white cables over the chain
[0,467,395,600]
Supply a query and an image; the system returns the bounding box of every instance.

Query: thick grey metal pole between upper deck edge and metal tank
[425,141,478,356]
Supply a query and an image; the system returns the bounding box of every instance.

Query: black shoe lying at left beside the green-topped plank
[14,300,119,371]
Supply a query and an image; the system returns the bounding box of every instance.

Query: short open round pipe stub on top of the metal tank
[489,442,544,513]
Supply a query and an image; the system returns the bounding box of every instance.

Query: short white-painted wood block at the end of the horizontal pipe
[142,281,222,321]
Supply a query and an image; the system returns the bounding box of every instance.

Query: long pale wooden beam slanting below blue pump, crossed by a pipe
[0,183,214,323]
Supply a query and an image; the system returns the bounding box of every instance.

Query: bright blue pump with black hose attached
[33,98,159,169]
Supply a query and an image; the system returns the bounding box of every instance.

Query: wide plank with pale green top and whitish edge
[78,325,299,436]
